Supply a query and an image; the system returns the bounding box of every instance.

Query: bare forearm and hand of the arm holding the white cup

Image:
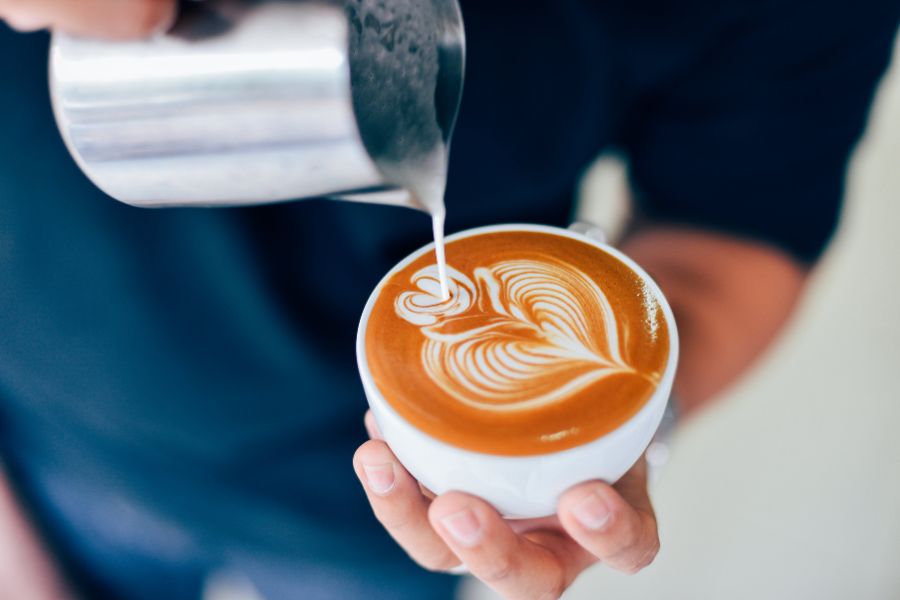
[353,227,806,600]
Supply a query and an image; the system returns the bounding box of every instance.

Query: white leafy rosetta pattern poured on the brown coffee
[394,259,657,412]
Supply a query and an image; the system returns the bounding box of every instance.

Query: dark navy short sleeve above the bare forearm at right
[624,2,900,262]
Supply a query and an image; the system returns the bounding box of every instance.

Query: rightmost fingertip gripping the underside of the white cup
[558,462,659,573]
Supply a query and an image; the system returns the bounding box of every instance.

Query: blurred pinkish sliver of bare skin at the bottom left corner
[0,463,72,600]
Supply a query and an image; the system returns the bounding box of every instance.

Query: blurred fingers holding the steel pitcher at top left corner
[0,0,176,39]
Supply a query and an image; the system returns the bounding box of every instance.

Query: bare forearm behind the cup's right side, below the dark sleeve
[622,227,806,414]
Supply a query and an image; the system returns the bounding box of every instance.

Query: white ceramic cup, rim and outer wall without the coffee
[356,224,678,518]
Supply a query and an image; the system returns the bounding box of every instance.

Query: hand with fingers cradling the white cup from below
[353,412,659,600]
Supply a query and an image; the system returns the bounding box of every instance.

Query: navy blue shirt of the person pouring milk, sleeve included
[0,0,898,597]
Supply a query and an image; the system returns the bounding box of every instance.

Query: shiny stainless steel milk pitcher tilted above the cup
[50,0,465,206]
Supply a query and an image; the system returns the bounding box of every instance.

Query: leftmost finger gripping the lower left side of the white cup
[353,440,460,571]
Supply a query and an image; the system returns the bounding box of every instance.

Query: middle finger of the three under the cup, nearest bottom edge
[429,492,586,600]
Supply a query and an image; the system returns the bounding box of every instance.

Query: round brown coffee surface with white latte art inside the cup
[365,231,669,455]
